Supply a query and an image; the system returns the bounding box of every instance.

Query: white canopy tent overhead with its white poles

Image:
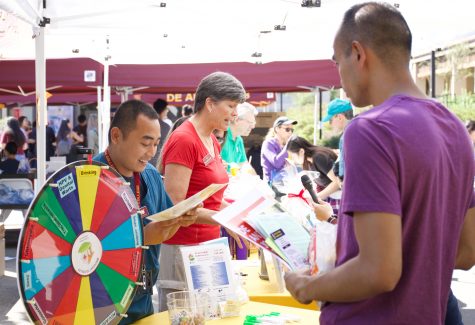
[0,0,475,187]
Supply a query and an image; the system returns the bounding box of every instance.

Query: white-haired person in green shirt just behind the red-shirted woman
[221,102,257,169]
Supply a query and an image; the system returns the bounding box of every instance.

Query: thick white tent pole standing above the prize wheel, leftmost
[35,27,48,193]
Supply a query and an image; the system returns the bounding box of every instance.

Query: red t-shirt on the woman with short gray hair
[162,121,229,245]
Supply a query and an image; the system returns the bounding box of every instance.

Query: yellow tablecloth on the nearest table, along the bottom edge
[134,301,320,325]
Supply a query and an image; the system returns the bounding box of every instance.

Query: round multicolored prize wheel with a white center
[18,161,143,325]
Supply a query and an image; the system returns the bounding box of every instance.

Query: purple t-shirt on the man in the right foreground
[320,95,475,325]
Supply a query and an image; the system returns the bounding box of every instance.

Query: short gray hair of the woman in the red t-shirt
[194,72,246,113]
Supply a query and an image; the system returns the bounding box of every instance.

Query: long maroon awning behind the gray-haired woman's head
[110,60,340,93]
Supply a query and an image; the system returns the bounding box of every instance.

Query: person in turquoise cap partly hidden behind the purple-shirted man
[318,98,353,200]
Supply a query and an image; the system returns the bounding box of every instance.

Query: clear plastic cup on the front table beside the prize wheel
[167,291,209,325]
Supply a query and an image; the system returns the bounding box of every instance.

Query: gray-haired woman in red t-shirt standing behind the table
[158,72,246,311]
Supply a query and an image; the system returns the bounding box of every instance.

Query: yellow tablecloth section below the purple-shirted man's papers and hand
[241,260,318,310]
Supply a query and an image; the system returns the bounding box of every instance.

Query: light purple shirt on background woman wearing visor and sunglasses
[261,138,288,181]
